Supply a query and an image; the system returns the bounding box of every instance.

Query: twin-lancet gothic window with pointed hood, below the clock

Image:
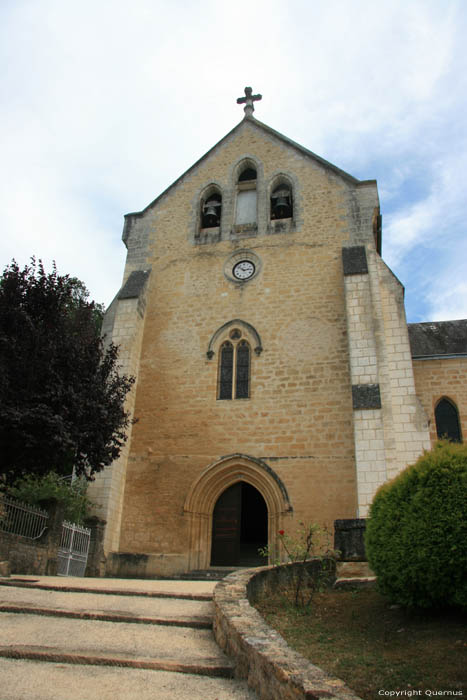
[217,328,251,399]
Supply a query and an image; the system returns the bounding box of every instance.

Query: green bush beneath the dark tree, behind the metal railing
[8,472,90,525]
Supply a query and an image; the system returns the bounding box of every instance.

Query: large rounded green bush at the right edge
[365,441,467,608]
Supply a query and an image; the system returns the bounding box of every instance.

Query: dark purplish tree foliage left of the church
[0,259,134,483]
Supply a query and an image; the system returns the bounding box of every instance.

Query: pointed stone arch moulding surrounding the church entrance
[183,454,293,570]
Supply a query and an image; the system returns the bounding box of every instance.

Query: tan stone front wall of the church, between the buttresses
[109,117,375,567]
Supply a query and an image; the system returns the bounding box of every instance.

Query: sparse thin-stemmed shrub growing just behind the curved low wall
[259,522,336,608]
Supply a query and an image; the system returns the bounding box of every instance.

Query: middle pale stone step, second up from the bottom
[0,612,233,677]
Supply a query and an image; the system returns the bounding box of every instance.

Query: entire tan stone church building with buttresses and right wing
[90,92,467,576]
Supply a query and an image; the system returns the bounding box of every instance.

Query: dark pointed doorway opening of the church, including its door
[211,481,268,566]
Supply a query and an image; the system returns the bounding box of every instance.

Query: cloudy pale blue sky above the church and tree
[0,0,467,322]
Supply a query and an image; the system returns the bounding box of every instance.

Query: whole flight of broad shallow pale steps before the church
[0,576,257,700]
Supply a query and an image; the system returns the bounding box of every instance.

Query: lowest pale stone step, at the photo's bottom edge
[0,658,257,700]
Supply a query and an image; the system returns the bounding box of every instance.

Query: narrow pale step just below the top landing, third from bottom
[0,586,213,629]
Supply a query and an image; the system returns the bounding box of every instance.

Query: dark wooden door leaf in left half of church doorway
[211,482,242,566]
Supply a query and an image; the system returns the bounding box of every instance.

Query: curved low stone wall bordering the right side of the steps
[214,564,359,700]
